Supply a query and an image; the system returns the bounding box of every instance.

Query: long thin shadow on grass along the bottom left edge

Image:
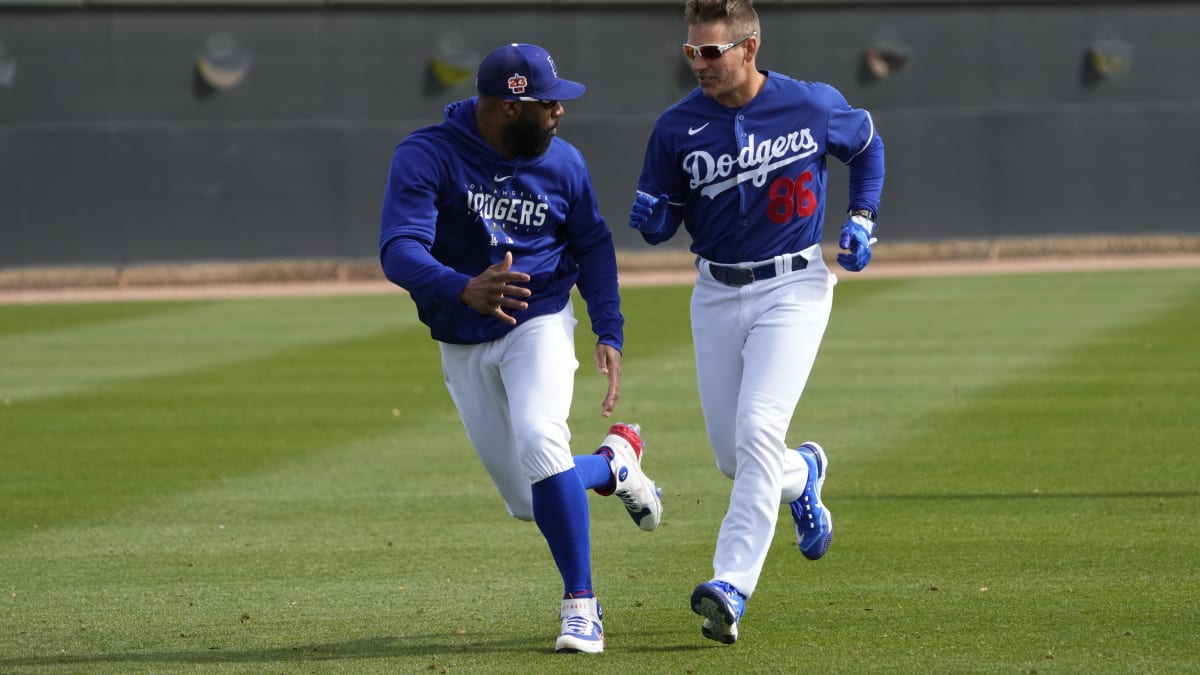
[0,634,704,671]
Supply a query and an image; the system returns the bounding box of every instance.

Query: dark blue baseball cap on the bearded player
[475,42,587,101]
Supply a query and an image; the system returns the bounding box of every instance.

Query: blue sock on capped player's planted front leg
[533,468,595,598]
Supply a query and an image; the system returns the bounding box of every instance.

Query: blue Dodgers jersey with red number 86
[637,71,882,264]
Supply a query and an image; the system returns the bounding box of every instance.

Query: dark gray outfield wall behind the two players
[0,2,1200,267]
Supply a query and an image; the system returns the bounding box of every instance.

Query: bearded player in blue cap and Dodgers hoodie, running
[379,43,662,653]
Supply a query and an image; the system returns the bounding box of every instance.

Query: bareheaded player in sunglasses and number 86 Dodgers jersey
[630,0,883,644]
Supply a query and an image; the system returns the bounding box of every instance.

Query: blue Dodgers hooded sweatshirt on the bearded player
[379,97,624,351]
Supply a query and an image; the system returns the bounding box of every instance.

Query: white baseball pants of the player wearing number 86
[691,246,838,597]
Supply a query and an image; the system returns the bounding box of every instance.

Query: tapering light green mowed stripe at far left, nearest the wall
[0,291,416,404]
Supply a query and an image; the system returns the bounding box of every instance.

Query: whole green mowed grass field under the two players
[0,269,1200,674]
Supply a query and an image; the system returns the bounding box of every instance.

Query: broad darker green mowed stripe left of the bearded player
[0,319,449,537]
